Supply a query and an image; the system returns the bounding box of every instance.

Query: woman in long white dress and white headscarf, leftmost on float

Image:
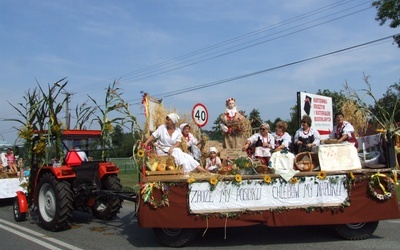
[142,113,207,172]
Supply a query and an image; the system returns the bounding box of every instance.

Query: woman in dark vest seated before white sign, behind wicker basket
[294,115,321,153]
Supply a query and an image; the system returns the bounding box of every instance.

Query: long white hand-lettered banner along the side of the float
[188,175,348,214]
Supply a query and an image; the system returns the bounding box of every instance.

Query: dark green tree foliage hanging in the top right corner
[372,0,400,48]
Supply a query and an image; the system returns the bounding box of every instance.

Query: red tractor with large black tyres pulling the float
[13,130,135,231]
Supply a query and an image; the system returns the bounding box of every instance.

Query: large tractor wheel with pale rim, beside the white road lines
[35,173,73,231]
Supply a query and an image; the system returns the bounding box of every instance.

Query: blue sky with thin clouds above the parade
[0,0,400,142]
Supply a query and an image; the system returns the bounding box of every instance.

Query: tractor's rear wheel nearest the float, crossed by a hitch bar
[92,175,122,220]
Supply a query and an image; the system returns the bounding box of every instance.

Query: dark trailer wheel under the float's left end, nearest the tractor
[153,228,197,247]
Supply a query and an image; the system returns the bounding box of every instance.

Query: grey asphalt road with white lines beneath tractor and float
[0,200,400,250]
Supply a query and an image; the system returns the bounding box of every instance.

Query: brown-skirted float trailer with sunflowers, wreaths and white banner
[137,93,400,247]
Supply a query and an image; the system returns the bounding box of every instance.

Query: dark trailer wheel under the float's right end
[334,221,379,240]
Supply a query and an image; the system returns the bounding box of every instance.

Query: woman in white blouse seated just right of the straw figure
[242,123,275,165]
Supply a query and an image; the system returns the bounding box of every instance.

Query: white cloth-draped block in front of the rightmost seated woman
[318,142,362,171]
